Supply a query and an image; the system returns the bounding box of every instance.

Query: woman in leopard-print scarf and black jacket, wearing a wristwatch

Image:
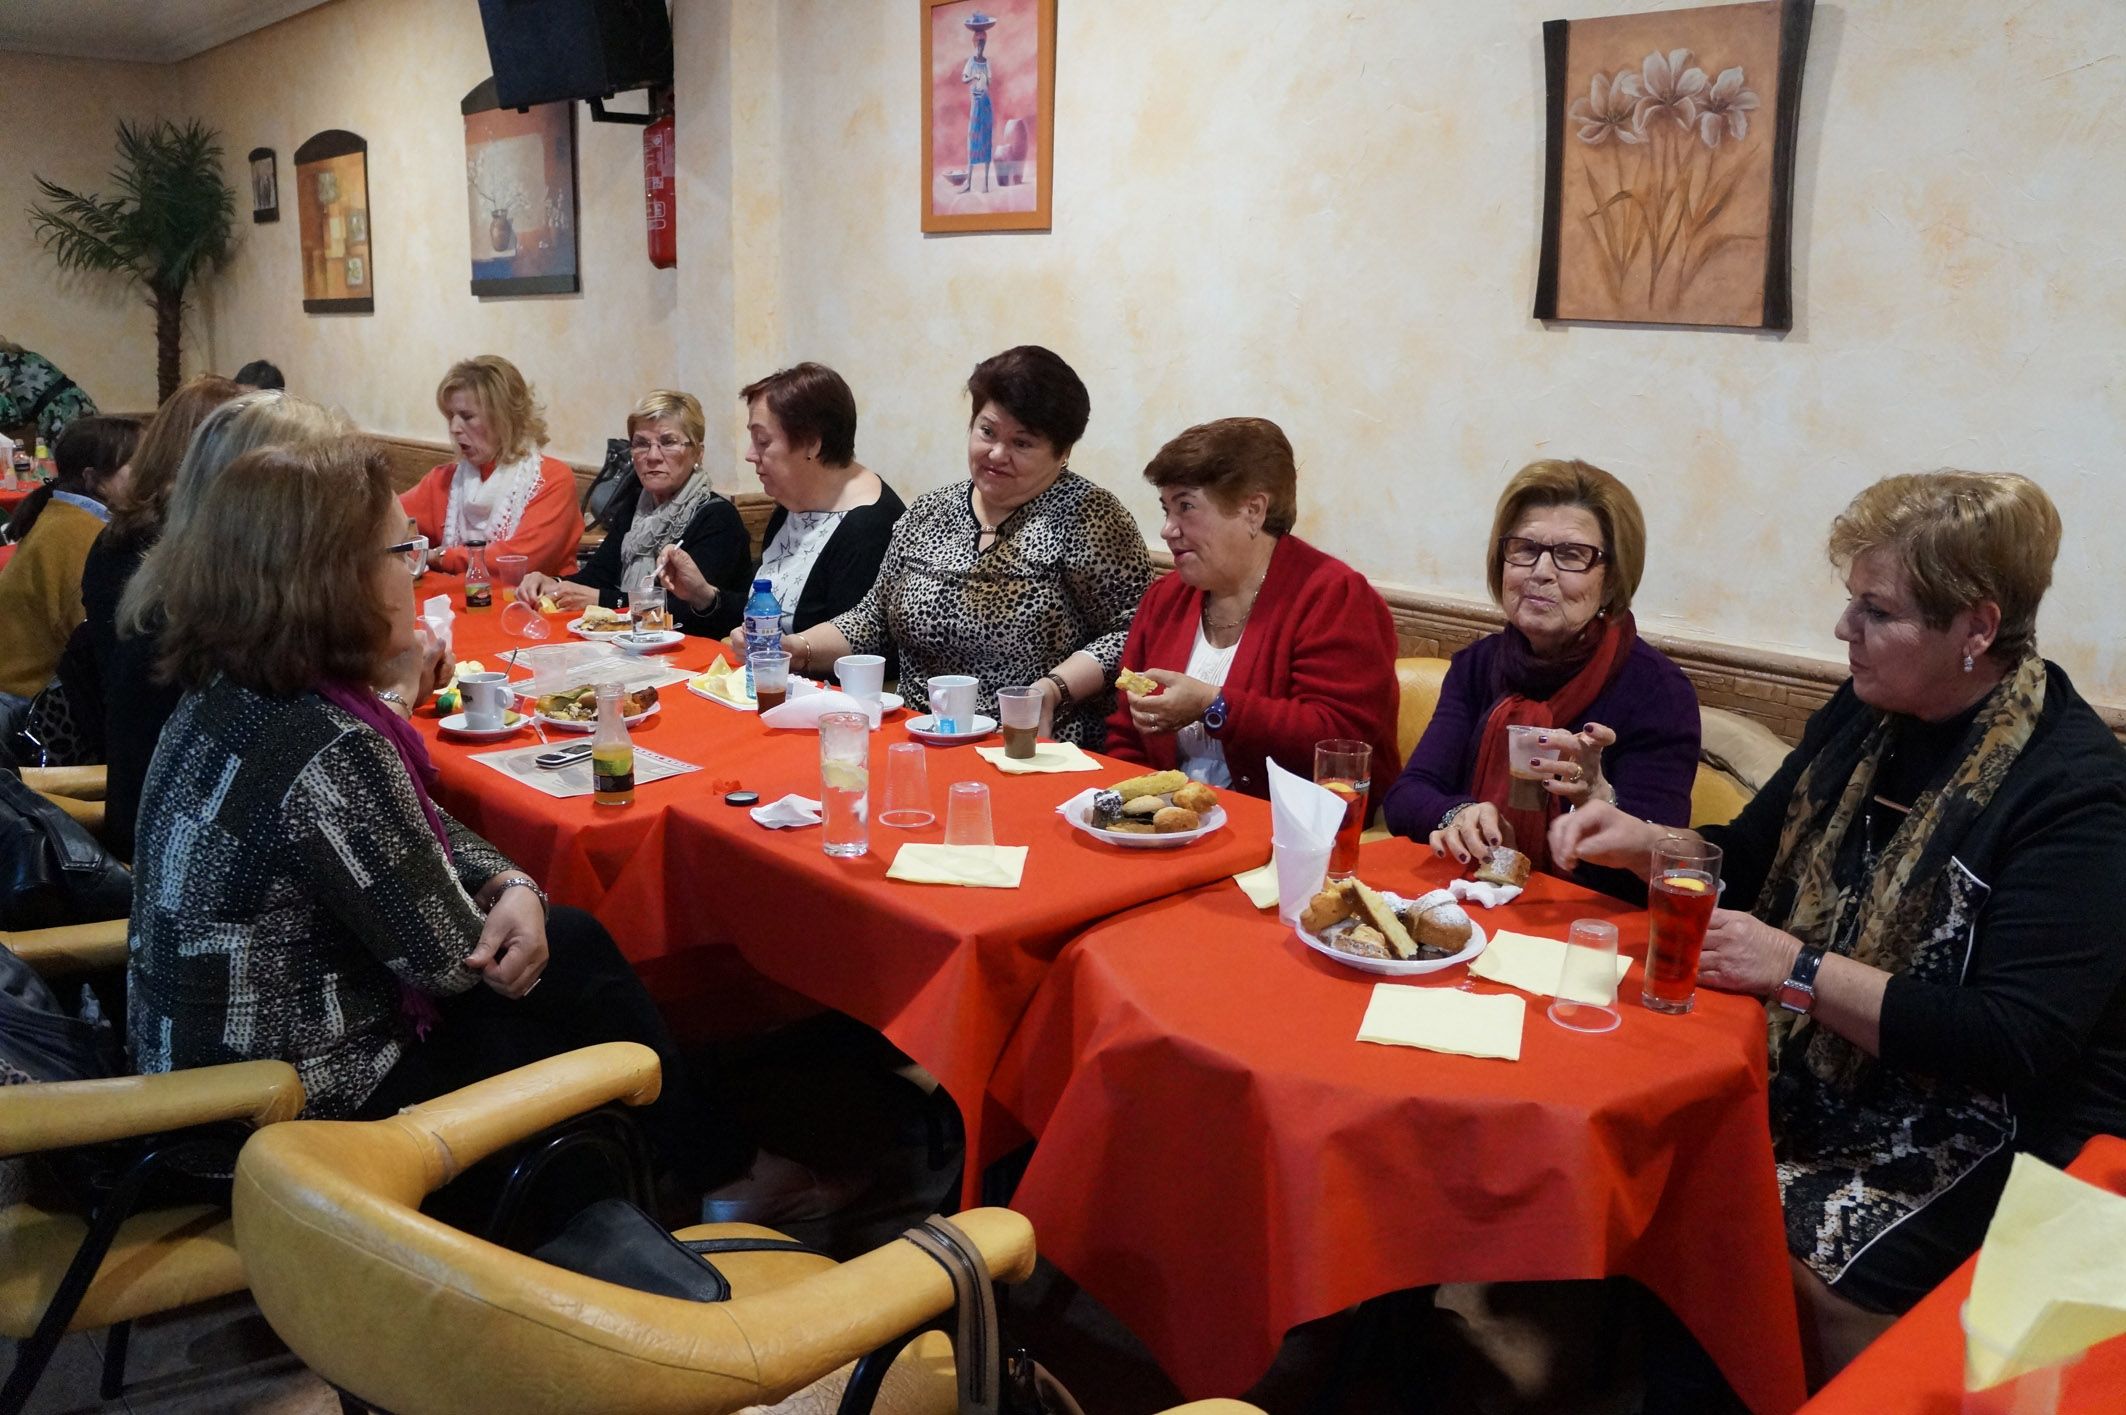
[1550,472,2126,1381]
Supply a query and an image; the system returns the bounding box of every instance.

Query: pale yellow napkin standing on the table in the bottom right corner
[1964,1154,2126,1390]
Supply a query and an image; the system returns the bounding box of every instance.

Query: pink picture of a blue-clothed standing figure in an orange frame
[921,0,1057,232]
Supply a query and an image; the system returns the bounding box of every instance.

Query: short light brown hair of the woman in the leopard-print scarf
[1830,470,2060,663]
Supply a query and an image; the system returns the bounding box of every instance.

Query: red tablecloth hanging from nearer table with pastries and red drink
[991,841,1803,1415]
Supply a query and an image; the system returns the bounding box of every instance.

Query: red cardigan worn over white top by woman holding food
[1108,535,1403,799]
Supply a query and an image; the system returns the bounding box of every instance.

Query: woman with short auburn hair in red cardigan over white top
[1108,419,1401,797]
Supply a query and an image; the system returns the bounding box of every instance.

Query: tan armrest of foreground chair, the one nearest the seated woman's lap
[395,1041,663,1192]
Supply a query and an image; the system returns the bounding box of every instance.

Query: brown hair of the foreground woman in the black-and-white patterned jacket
[149,438,393,697]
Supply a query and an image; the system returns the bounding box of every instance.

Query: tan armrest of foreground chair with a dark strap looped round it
[721,1209,1033,1394]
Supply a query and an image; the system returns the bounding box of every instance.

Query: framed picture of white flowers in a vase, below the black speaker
[459,79,583,295]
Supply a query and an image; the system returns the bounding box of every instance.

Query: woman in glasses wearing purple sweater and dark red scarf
[1386,461,1699,899]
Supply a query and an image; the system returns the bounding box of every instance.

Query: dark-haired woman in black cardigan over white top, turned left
[663,363,906,644]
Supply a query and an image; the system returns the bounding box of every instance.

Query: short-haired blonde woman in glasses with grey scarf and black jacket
[517,389,753,637]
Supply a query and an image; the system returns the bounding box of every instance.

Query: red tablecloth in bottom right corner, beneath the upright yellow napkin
[1803,1135,2126,1415]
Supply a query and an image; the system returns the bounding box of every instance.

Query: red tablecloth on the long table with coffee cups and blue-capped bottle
[417,576,1269,1196]
